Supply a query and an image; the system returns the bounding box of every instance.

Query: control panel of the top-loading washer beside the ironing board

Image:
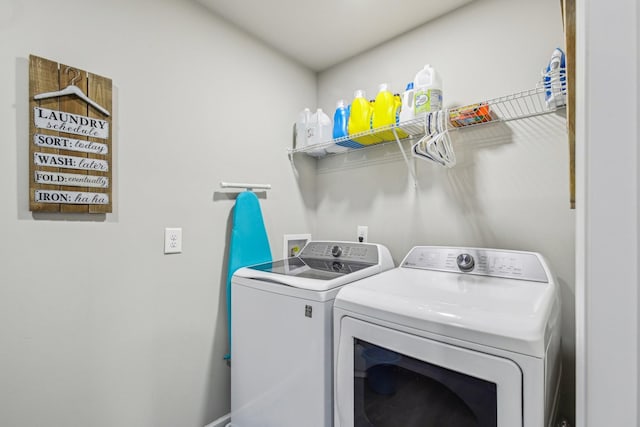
[299,241,378,265]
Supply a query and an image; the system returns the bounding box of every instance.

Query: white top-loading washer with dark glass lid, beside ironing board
[231,241,394,427]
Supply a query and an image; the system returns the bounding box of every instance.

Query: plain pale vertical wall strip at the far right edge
[576,0,640,427]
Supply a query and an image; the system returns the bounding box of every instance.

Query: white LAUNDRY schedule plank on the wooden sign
[33,107,109,139]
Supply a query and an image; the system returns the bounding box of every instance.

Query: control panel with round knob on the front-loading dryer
[402,246,549,283]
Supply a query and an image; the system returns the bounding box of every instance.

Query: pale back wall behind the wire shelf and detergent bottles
[317,0,575,418]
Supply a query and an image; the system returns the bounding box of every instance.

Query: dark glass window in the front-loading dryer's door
[353,339,497,427]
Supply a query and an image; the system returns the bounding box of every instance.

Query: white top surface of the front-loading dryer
[334,248,559,357]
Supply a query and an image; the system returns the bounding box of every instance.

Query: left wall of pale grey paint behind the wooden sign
[0,0,316,427]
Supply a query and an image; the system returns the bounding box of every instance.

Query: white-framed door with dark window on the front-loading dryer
[334,317,522,427]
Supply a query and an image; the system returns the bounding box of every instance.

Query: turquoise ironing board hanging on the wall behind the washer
[225,191,272,359]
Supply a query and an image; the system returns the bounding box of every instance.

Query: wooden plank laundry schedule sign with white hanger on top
[29,55,113,213]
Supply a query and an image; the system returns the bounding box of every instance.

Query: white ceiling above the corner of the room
[196,0,472,71]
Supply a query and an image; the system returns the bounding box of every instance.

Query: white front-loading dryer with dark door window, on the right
[334,246,561,427]
